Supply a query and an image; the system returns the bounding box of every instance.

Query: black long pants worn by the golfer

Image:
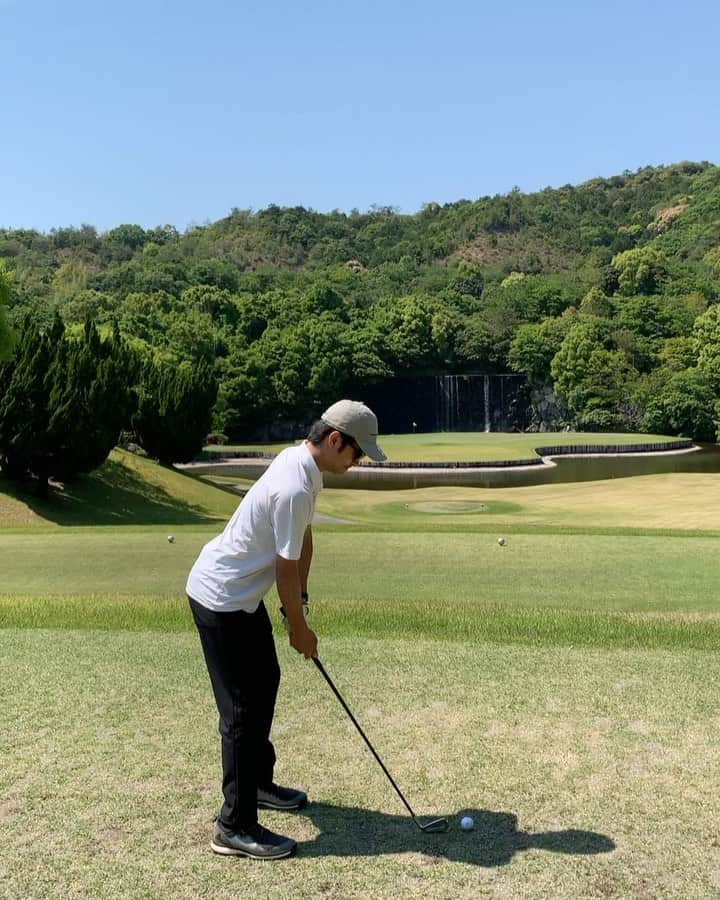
[188,598,280,831]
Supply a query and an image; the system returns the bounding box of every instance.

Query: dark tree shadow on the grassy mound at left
[0,459,225,525]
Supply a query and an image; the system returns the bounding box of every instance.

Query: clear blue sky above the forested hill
[0,0,720,231]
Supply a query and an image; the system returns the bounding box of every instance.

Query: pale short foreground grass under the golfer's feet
[0,629,720,900]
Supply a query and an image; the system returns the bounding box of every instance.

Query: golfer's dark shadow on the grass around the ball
[298,803,615,868]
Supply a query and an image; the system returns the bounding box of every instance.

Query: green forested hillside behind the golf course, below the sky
[0,162,720,442]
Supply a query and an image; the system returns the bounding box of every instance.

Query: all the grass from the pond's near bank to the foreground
[0,446,720,898]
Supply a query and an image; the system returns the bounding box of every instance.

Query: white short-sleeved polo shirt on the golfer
[185,441,322,612]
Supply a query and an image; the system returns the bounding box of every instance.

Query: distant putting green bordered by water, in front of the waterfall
[205,431,677,462]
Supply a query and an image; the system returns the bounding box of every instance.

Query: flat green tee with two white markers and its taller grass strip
[0,529,720,649]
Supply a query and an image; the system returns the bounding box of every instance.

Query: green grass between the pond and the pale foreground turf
[0,454,720,648]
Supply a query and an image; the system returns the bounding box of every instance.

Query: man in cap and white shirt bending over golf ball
[186,400,386,859]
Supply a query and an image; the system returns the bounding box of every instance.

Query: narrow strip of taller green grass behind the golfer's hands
[0,594,720,651]
